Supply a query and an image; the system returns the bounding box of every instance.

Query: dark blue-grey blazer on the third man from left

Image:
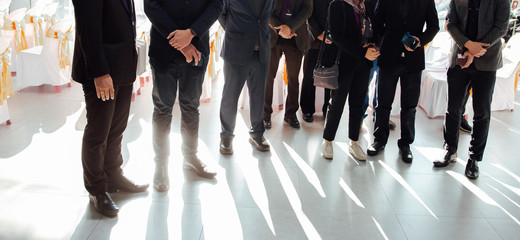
[218,0,274,64]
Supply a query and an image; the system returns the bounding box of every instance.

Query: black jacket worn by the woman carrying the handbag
[330,0,375,69]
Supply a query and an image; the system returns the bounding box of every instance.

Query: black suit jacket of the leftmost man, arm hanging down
[72,0,137,86]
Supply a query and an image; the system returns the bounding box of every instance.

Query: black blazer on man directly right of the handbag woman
[374,0,439,71]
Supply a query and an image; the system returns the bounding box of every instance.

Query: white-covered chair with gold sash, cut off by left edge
[0,36,14,125]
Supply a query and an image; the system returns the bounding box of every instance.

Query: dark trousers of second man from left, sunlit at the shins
[150,57,208,164]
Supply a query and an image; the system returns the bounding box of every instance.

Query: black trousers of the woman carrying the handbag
[323,61,370,141]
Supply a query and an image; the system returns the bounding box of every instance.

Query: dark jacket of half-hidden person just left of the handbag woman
[308,0,332,49]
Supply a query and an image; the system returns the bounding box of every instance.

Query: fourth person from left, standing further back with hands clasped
[264,0,313,129]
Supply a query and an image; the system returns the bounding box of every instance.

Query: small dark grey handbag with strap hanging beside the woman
[313,7,341,90]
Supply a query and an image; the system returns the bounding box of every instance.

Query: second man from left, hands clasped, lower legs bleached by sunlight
[144,0,223,191]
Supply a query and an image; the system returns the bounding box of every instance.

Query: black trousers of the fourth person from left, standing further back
[264,38,303,119]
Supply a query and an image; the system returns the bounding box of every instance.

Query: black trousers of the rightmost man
[444,65,496,161]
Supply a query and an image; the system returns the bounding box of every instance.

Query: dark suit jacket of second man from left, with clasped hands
[144,0,223,61]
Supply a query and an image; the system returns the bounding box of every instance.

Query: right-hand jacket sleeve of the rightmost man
[481,0,510,45]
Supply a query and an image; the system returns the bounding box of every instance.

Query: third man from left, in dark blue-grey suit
[219,0,274,154]
